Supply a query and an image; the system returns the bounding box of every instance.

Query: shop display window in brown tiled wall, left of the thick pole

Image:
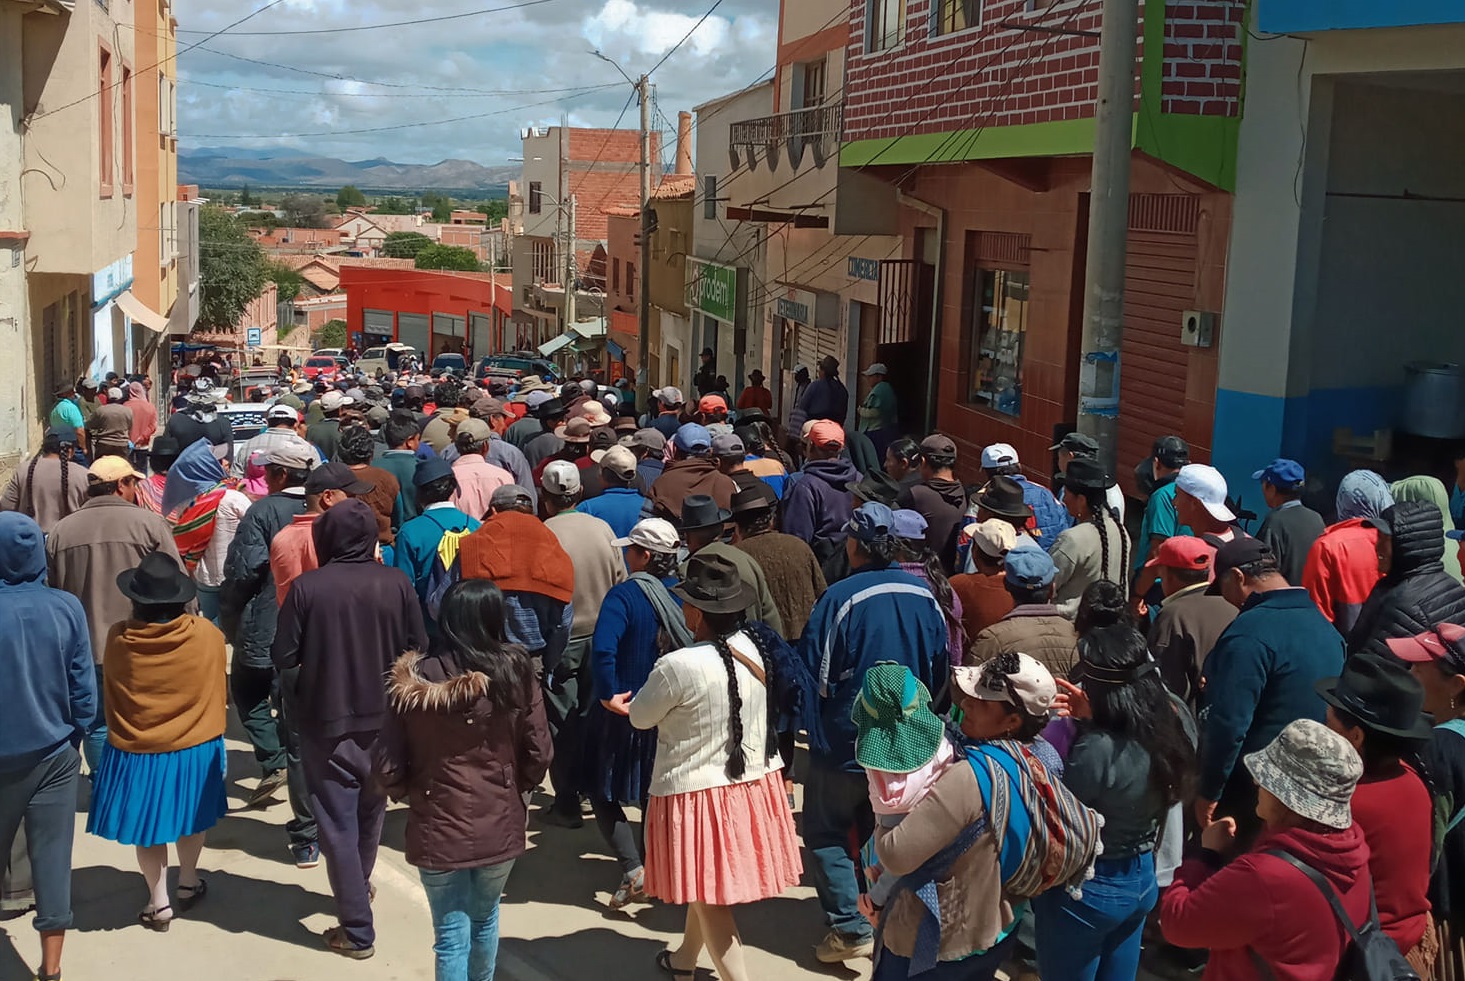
[968,269,1028,416]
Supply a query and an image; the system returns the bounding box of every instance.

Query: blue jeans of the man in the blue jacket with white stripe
[804,758,875,937]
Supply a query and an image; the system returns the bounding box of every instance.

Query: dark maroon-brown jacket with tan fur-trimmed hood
[372,652,552,871]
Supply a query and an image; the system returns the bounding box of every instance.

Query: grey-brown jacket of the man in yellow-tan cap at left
[45,495,183,665]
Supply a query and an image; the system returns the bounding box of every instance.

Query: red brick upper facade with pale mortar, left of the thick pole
[844,0,1113,141]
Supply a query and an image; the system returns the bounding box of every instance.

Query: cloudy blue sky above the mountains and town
[176,0,778,167]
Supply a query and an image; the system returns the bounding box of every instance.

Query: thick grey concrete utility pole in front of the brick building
[1078,0,1138,473]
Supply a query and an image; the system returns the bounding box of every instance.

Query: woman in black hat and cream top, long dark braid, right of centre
[1049,458,1130,619]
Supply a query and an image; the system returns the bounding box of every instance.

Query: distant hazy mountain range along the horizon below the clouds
[179,148,519,192]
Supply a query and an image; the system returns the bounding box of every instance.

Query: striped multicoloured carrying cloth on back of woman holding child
[964,739,1103,899]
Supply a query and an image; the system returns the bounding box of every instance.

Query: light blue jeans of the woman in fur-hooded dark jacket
[418,858,514,981]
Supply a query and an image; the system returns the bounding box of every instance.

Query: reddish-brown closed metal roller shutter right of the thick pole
[1118,195,1216,493]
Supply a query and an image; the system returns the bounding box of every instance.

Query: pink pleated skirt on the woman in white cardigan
[646,770,804,906]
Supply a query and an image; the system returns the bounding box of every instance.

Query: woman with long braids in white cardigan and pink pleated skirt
[614,556,803,981]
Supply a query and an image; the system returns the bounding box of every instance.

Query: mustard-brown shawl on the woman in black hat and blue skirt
[103,615,229,753]
